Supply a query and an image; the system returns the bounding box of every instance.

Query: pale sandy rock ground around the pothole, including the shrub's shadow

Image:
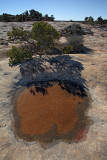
[0,22,107,160]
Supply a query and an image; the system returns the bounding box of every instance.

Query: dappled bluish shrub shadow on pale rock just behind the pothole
[18,55,85,85]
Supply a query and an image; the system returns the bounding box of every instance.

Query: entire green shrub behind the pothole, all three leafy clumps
[7,22,59,64]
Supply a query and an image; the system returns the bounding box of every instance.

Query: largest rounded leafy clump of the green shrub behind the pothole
[32,22,59,50]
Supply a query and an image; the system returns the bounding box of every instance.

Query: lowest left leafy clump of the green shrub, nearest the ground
[7,46,32,65]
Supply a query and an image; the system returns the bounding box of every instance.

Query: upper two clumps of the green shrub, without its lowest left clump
[7,22,59,50]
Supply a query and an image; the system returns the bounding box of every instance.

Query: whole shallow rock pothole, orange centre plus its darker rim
[13,81,89,143]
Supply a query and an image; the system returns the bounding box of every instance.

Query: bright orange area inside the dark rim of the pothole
[17,84,83,136]
